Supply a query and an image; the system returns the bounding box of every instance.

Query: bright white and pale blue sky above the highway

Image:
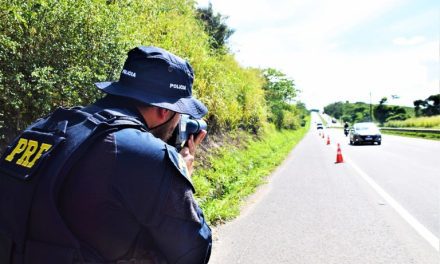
[197,0,440,109]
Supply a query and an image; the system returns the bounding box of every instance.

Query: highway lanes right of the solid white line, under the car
[323,125,440,237]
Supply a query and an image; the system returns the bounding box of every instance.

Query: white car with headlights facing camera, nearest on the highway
[350,122,382,145]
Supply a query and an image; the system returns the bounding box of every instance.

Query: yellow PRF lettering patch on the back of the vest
[5,138,52,168]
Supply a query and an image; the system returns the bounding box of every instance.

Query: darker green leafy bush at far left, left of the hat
[0,0,121,145]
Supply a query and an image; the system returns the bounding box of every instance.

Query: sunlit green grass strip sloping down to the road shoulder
[192,117,310,225]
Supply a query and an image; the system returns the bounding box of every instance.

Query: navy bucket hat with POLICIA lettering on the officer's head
[95,46,208,118]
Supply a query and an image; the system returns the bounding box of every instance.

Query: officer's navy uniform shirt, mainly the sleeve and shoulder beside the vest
[56,97,211,264]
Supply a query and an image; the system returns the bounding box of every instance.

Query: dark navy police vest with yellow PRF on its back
[0,107,146,264]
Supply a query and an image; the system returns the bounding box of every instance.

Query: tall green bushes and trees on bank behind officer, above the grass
[0,0,307,151]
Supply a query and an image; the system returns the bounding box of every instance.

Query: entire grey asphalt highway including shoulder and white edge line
[210,118,440,264]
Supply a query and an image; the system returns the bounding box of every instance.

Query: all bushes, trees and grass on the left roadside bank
[0,0,309,226]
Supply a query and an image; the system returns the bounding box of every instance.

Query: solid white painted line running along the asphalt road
[344,146,440,251]
